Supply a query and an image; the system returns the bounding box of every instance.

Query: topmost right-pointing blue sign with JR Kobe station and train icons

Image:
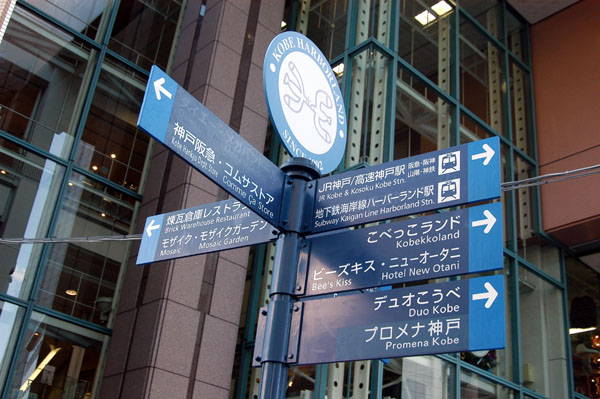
[311,137,500,233]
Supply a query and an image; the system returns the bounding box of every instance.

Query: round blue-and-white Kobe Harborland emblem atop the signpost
[263,32,347,174]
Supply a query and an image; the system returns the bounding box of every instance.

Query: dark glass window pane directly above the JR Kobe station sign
[394,68,453,159]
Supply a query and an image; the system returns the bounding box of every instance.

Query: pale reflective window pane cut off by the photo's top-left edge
[22,0,111,41]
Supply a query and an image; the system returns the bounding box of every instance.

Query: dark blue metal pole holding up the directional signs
[255,158,319,399]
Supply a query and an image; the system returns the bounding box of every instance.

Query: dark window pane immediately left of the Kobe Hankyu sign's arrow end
[76,59,149,191]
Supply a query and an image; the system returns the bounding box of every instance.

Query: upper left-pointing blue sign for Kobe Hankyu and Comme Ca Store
[138,66,285,226]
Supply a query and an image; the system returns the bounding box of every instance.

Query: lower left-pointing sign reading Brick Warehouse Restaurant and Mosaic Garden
[136,199,279,265]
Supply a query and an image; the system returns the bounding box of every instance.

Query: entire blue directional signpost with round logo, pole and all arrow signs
[137,32,504,398]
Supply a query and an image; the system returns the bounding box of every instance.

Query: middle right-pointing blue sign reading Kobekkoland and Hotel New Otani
[297,202,504,296]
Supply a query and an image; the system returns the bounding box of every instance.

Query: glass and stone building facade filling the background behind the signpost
[0,0,600,399]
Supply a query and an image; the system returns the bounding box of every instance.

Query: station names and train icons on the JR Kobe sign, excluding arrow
[313,151,465,231]
